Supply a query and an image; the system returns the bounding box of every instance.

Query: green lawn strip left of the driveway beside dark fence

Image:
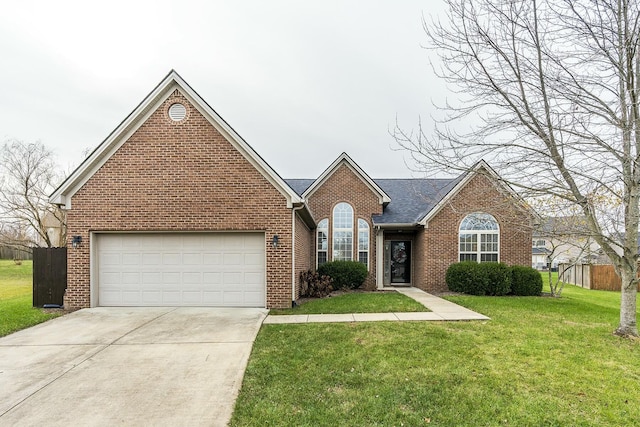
[0,260,58,337]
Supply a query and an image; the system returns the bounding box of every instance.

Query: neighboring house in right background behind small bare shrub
[532,216,601,270]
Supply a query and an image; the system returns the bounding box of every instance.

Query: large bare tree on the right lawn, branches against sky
[394,0,640,336]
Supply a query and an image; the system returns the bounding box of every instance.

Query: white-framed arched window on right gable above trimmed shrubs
[459,212,500,262]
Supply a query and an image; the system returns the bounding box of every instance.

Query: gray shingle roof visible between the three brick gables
[285,176,463,225]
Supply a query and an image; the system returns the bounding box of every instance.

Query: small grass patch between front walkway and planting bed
[269,292,429,315]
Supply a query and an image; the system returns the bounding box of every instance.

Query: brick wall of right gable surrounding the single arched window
[412,175,531,292]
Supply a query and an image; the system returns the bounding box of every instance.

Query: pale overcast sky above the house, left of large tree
[0,0,446,178]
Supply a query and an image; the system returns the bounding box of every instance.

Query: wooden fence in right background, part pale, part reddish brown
[558,264,640,292]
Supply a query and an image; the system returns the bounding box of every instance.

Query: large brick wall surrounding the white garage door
[65,91,292,308]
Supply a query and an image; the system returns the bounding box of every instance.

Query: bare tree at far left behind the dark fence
[0,140,66,248]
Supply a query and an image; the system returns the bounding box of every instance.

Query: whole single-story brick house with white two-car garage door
[51,71,532,308]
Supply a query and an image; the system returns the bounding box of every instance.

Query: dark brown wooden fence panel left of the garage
[33,248,67,307]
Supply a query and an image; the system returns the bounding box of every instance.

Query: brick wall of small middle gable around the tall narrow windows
[308,164,382,288]
